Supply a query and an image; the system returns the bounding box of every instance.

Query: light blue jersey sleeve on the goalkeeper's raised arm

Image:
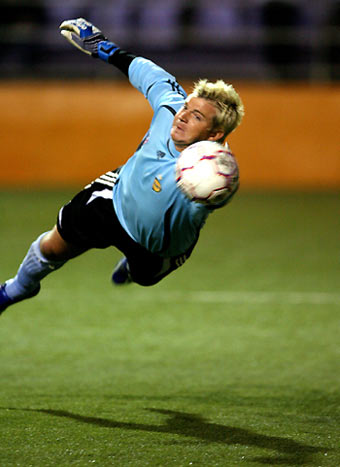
[129,57,186,111]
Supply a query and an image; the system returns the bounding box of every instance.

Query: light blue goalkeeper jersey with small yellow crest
[113,57,211,257]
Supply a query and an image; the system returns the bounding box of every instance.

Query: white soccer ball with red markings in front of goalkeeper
[176,141,238,205]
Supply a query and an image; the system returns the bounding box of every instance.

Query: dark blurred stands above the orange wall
[0,0,340,81]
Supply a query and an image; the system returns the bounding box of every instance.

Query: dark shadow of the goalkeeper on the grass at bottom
[2,408,326,466]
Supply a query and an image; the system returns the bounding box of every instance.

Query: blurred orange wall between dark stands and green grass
[0,82,340,189]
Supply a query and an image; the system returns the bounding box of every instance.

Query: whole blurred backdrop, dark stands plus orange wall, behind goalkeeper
[0,0,340,189]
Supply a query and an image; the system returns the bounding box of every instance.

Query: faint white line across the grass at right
[134,290,340,306]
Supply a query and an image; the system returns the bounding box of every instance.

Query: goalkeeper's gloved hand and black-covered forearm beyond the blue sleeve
[59,18,136,76]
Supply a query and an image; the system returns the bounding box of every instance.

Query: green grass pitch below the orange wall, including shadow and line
[0,191,340,467]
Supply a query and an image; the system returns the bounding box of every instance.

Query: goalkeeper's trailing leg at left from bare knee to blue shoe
[0,227,85,313]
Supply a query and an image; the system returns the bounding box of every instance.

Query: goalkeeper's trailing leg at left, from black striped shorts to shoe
[0,171,119,313]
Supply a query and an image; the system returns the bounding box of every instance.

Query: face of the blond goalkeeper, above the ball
[170,96,223,151]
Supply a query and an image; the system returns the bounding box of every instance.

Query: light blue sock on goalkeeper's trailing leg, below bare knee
[6,232,66,299]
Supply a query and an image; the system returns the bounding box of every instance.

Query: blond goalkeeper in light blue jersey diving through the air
[0,18,244,313]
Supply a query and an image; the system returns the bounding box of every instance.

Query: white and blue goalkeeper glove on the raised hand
[59,18,119,62]
